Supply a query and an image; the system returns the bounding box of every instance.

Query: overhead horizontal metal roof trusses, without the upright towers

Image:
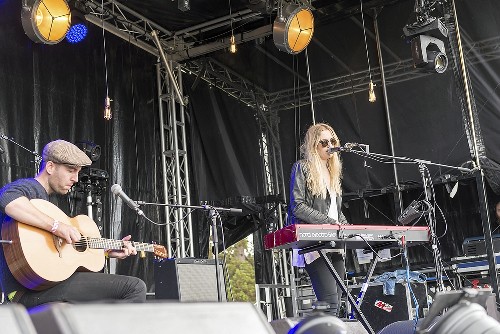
[81,0,500,116]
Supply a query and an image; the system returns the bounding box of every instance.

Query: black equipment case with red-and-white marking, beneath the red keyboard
[350,283,428,332]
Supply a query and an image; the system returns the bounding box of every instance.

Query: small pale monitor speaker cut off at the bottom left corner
[0,304,36,334]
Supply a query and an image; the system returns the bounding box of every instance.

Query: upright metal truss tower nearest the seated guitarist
[157,64,194,258]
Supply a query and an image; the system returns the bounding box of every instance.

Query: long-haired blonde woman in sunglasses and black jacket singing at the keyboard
[287,123,347,315]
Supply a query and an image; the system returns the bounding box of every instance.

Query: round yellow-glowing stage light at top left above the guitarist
[21,0,71,44]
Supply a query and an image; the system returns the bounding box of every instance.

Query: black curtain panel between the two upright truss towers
[186,78,264,257]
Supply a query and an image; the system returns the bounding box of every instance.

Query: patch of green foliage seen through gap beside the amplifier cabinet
[226,239,255,303]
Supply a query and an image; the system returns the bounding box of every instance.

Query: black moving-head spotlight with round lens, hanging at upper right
[403,5,448,73]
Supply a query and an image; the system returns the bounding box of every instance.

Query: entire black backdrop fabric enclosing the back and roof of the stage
[0,0,500,288]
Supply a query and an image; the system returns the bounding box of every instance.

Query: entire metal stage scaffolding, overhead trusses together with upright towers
[79,0,500,316]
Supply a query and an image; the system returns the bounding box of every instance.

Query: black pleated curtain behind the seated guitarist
[0,0,164,287]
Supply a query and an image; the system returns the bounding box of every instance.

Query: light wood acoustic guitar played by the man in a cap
[2,199,167,291]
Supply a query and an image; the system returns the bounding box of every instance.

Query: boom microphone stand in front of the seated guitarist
[136,201,243,302]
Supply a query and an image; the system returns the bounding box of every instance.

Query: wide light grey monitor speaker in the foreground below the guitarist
[29,302,274,334]
